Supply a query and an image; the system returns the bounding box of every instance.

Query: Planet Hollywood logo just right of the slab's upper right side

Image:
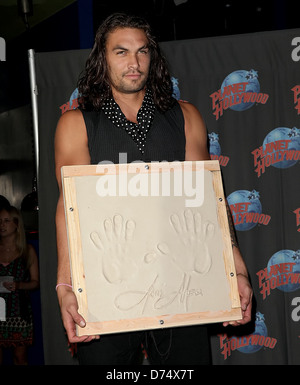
[227,190,271,231]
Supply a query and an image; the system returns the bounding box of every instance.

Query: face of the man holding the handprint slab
[106,28,150,94]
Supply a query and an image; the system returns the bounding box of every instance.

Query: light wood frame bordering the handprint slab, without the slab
[62,161,242,335]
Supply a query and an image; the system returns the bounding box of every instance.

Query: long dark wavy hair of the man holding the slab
[78,13,175,112]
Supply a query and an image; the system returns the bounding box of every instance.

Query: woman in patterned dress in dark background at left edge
[0,206,39,365]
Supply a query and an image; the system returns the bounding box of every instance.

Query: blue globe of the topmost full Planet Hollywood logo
[221,69,260,111]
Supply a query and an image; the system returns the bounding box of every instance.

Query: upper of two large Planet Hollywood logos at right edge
[251,127,300,177]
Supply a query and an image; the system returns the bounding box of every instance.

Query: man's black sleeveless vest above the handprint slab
[82,102,185,164]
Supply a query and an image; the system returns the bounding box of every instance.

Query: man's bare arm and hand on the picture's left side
[55,110,98,342]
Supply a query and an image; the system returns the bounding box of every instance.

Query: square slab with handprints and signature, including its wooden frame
[62,161,242,335]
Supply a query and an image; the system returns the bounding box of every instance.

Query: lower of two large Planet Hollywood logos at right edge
[256,250,300,299]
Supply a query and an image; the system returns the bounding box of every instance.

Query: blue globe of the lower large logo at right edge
[267,250,300,292]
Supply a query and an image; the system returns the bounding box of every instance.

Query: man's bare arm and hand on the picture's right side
[180,102,252,326]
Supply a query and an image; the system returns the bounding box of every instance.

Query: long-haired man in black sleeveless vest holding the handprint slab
[55,14,252,365]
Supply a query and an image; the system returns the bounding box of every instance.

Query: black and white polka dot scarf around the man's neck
[102,90,155,154]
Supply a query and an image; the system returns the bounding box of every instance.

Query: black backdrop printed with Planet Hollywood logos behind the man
[36,29,300,365]
